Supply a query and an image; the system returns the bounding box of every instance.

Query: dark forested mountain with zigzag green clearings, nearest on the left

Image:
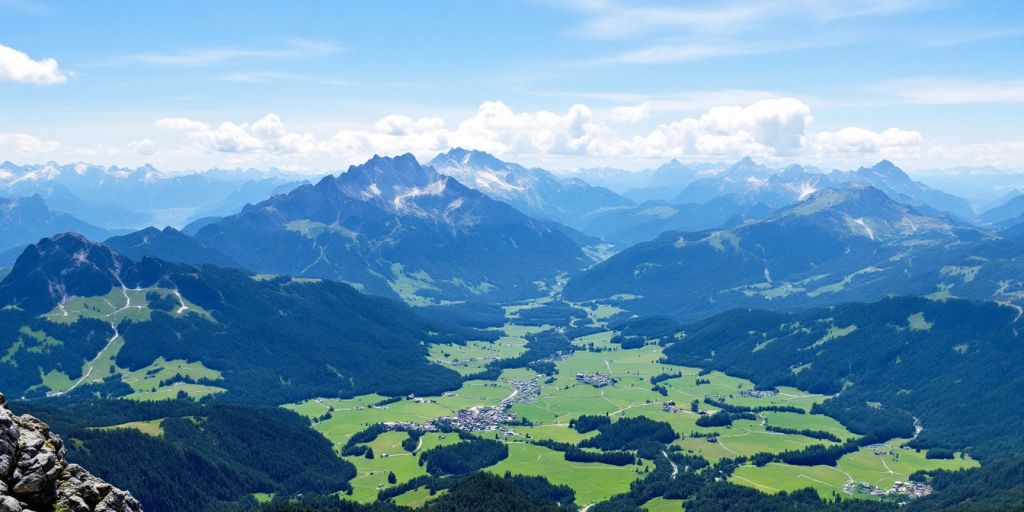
[0,233,468,404]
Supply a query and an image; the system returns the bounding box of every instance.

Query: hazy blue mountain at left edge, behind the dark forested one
[0,196,111,252]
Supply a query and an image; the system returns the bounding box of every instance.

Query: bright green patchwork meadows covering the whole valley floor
[286,309,976,512]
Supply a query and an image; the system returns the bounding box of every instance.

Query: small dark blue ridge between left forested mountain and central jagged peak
[103,227,242,268]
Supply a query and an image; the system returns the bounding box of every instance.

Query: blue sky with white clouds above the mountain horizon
[0,0,1024,172]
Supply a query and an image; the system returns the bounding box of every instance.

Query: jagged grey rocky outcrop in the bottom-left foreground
[0,393,142,512]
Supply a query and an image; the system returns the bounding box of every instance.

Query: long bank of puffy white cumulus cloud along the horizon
[146,97,1021,169]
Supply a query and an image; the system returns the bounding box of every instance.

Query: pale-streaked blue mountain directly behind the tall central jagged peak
[428,147,633,229]
